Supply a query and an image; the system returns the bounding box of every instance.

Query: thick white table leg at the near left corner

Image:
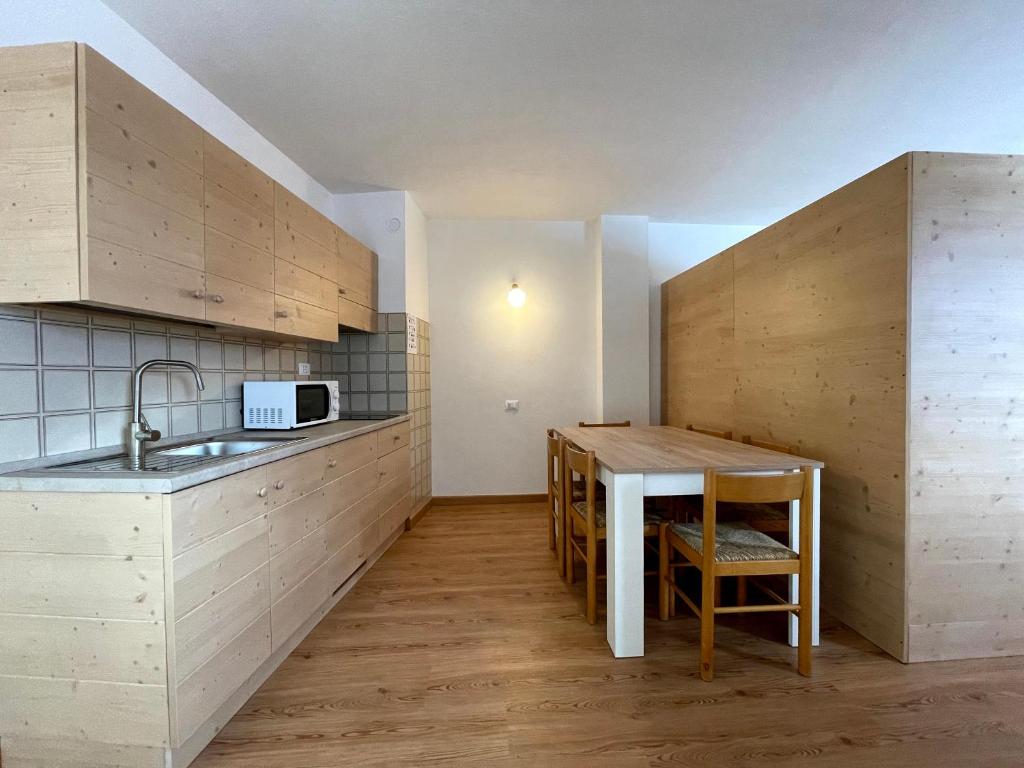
[606,474,644,658]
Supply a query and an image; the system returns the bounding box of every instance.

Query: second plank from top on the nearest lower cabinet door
[173,514,270,618]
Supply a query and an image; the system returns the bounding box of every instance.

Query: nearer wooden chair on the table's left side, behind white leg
[562,440,662,624]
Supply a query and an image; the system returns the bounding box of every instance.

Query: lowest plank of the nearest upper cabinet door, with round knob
[84,238,206,319]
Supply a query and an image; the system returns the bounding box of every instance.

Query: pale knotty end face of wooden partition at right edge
[907,153,1024,660]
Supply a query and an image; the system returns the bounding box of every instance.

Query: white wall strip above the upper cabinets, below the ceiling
[0,0,331,215]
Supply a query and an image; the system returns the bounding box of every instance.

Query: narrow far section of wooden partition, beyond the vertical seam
[662,251,736,429]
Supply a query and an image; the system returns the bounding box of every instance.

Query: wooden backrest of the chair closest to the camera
[703,467,814,567]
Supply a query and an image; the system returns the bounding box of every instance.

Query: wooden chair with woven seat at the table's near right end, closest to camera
[658,467,813,681]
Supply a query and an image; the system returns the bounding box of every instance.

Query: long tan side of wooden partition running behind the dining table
[663,157,908,658]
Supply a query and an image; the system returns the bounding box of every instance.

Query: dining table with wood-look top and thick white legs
[557,427,824,657]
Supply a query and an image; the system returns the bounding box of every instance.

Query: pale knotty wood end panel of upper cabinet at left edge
[0,43,79,302]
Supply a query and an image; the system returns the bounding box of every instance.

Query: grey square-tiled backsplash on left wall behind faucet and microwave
[0,304,309,463]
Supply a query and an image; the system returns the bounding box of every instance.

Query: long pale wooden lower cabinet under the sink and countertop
[0,427,411,768]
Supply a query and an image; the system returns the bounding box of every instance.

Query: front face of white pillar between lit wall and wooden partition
[598,216,650,426]
